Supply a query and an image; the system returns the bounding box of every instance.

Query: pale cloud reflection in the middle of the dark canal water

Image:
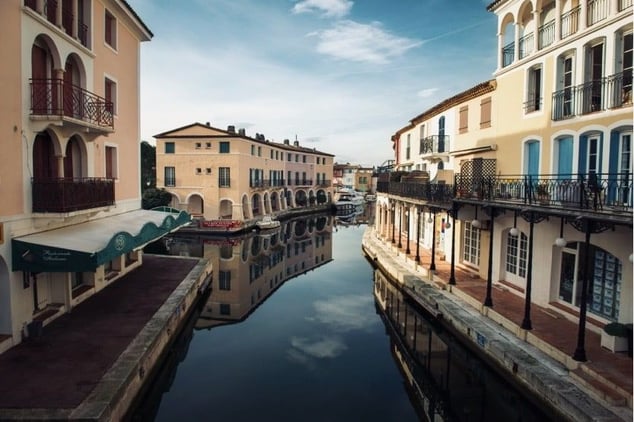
[287,294,379,369]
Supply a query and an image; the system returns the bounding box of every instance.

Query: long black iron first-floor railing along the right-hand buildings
[377,172,634,212]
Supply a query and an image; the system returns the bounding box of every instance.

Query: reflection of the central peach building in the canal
[159,214,333,328]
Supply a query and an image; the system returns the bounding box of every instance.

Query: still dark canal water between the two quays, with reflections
[129,215,548,422]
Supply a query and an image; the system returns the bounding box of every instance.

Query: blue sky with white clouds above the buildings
[128,0,497,166]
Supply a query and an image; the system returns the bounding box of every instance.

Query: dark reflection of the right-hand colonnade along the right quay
[374,269,553,422]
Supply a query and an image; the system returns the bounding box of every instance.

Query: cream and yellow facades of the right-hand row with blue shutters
[377,0,633,361]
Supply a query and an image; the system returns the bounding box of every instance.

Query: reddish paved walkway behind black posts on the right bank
[369,228,633,416]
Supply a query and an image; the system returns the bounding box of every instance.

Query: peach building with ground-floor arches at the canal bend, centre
[155,123,333,227]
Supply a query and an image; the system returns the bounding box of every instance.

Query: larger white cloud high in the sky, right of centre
[309,20,421,64]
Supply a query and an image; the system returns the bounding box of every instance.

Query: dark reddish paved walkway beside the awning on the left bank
[0,255,199,420]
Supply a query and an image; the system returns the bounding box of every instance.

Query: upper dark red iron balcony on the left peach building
[31,79,114,130]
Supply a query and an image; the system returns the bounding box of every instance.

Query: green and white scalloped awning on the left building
[11,208,191,273]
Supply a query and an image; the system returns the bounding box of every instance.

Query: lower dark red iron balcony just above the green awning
[31,177,115,213]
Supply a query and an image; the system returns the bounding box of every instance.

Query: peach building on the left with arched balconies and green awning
[0,0,188,352]
